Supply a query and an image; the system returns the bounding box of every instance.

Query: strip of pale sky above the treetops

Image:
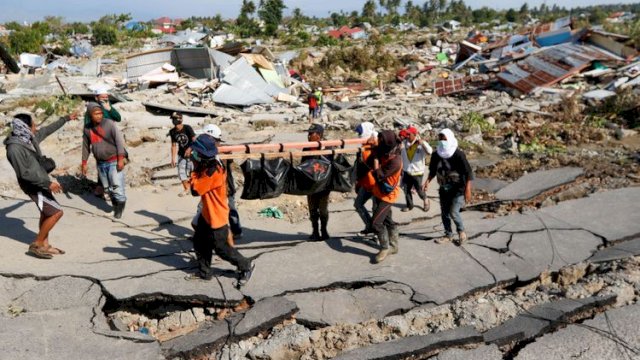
[0,0,637,23]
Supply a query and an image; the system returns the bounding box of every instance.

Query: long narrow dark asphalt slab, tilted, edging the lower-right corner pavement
[484,296,615,346]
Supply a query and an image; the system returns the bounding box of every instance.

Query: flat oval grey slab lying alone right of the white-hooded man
[496,167,584,201]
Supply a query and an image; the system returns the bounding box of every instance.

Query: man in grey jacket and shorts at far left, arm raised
[4,114,78,259]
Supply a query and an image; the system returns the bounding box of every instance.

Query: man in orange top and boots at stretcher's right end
[371,130,402,263]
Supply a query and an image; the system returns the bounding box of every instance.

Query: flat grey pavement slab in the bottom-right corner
[515,304,640,360]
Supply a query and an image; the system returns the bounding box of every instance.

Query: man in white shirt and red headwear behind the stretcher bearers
[402,126,433,212]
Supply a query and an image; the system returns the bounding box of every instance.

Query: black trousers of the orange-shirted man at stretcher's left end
[193,216,251,278]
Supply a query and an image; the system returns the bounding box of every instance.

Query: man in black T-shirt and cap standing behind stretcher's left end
[169,112,196,196]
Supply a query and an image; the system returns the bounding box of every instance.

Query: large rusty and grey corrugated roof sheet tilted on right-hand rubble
[498,44,610,94]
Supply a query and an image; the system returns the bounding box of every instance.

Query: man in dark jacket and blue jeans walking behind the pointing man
[82,102,127,219]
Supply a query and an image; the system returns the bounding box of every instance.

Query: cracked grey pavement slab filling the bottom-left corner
[0,277,161,360]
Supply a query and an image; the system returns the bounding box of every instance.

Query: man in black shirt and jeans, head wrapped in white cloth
[424,129,473,244]
